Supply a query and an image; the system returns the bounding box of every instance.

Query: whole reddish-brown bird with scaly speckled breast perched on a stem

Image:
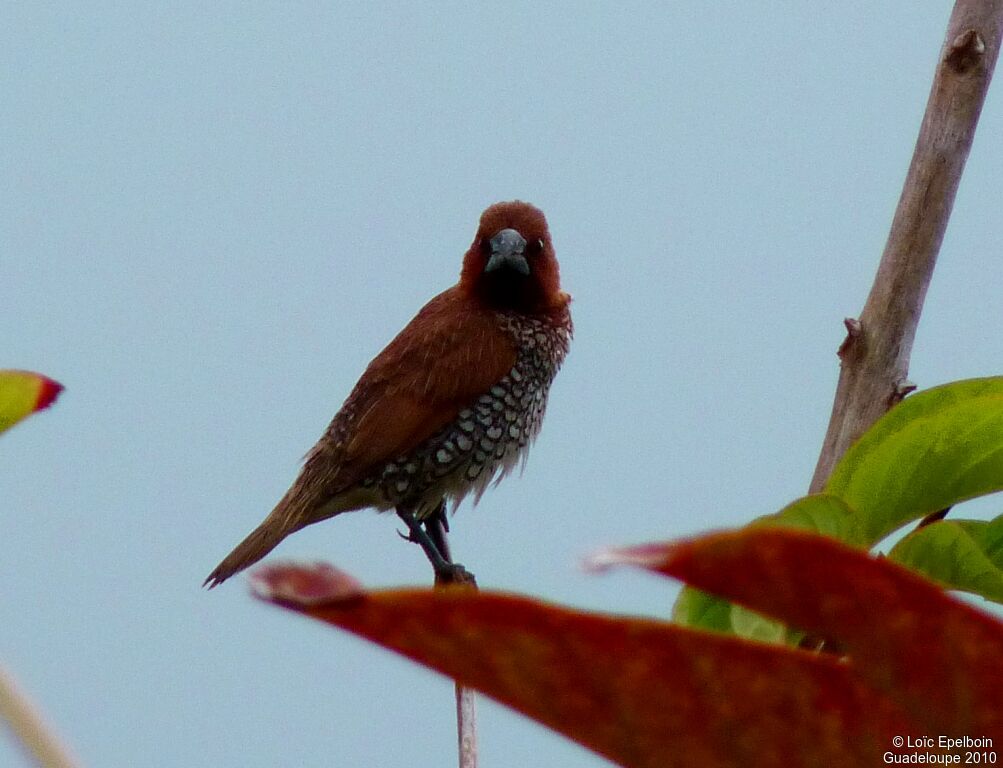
[206,201,572,588]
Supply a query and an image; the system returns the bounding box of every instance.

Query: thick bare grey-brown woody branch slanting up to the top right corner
[810,0,1003,492]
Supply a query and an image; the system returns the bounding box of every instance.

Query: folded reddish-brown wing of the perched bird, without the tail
[305,289,516,493]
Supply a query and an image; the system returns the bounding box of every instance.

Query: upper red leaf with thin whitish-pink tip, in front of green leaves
[593,528,1003,744]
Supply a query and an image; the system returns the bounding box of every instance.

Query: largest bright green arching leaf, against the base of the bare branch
[825,377,1003,544]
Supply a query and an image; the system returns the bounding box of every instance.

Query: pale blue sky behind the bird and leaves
[0,2,1003,768]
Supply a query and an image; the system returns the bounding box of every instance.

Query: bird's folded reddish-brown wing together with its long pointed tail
[206,289,516,587]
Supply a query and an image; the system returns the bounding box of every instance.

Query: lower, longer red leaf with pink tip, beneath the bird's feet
[253,566,909,768]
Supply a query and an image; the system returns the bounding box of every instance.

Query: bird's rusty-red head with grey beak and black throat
[459,201,568,312]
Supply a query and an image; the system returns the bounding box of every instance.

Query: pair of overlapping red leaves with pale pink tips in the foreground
[255,529,1003,768]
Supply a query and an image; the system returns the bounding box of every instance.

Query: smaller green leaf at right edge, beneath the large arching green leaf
[888,515,1003,603]
